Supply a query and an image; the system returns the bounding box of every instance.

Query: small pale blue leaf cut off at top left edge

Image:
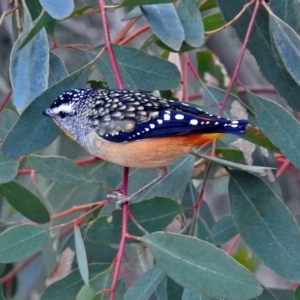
[39,0,74,20]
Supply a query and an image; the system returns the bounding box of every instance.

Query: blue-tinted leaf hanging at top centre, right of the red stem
[141,4,185,50]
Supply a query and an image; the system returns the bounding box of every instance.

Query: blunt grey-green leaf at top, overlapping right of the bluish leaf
[177,0,205,48]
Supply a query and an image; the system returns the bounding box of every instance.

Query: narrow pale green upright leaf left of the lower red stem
[74,226,89,285]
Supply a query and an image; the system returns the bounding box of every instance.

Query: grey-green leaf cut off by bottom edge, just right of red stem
[124,265,165,300]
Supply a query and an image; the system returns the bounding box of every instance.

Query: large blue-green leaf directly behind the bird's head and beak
[3,61,91,157]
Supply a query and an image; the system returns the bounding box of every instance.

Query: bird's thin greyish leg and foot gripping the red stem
[107,167,168,209]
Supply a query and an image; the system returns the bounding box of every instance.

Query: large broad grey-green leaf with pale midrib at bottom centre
[139,232,262,300]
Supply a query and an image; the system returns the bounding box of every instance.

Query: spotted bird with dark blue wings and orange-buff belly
[43,88,248,203]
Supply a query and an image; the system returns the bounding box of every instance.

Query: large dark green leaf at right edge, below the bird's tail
[229,171,300,281]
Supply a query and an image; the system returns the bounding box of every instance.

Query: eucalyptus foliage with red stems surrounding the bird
[0,0,300,300]
